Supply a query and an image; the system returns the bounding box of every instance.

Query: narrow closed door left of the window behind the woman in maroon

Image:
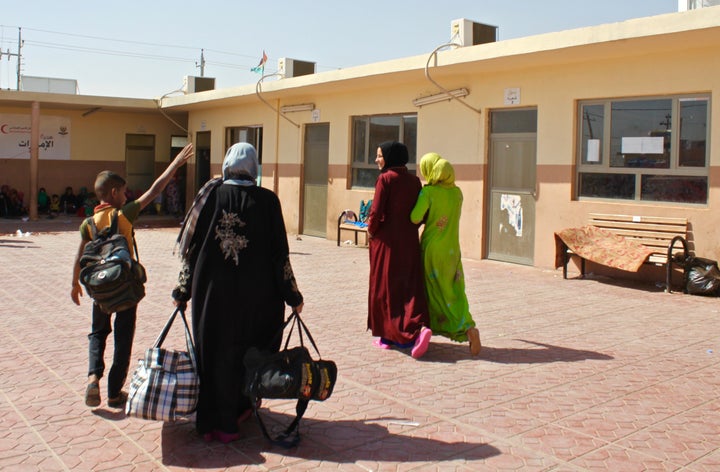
[301,123,330,238]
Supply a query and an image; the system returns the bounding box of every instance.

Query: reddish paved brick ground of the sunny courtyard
[0,218,720,471]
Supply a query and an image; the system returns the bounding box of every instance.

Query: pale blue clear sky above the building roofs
[0,0,678,98]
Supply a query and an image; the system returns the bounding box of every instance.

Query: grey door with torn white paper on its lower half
[486,109,537,265]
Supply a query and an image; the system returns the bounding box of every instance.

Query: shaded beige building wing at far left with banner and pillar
[0,90,187,204]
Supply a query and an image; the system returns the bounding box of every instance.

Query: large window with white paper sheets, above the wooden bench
[577,96,710,204]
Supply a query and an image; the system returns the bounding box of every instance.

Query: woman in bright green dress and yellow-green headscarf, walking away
[410,152,481,356]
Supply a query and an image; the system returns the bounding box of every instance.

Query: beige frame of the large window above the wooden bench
[573,92,712,206]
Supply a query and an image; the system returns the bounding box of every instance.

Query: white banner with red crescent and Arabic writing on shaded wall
[0,114,70,160]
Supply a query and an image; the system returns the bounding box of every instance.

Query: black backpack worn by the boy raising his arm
[80,211,147,313]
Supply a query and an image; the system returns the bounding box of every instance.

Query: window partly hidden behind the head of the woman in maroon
[351,114,417,188]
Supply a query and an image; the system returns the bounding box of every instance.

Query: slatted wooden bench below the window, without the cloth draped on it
[563,213,689,292]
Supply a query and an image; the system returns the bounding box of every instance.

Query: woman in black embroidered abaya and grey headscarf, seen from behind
[173,143,303,442]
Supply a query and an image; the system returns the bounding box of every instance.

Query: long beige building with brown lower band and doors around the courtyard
[0,7,720,277]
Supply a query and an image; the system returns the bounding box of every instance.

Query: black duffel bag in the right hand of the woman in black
[243,310,337,448]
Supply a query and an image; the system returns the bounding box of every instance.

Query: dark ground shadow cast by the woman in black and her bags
[161,414,500,469]
